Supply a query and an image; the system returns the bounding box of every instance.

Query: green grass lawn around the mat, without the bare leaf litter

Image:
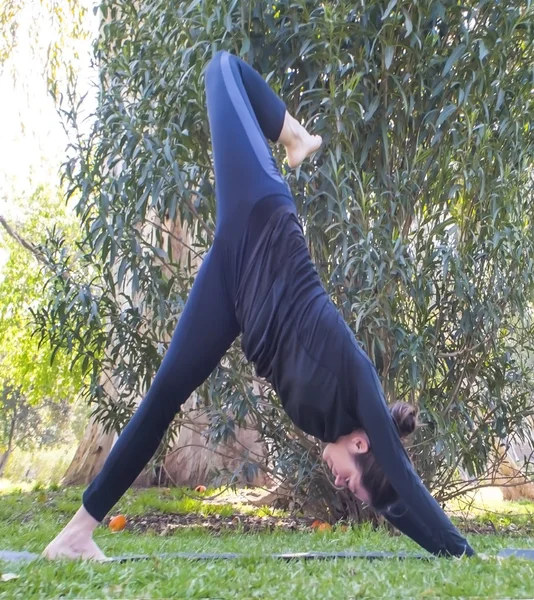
[0,488,534,600]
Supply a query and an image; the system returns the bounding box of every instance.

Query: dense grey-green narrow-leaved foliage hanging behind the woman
[33,0,534,514]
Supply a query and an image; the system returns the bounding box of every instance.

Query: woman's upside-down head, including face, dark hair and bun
[323,402,417,509]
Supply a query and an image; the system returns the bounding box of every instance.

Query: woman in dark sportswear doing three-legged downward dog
[43,52,474,559]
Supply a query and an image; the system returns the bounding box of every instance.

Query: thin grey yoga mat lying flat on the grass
[0,548,534,563]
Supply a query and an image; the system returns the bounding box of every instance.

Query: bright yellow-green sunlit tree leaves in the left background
[0,187,82,404]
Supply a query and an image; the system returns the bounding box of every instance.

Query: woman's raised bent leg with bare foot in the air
[206,51,321,230]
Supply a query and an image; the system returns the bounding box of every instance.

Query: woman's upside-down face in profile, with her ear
[323,430,371,504]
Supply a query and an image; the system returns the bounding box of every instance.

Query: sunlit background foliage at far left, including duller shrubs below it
[0,187,87,466]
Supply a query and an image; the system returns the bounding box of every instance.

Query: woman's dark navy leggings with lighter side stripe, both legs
[83,52,294,521]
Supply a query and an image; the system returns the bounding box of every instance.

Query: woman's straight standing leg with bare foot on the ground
[44,241,239,558]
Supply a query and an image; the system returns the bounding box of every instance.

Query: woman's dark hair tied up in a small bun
[355,402,417,510]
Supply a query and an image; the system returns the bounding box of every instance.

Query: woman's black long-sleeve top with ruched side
[236,206,474,556]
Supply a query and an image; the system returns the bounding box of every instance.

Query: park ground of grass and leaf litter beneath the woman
[0,480,534,600]
